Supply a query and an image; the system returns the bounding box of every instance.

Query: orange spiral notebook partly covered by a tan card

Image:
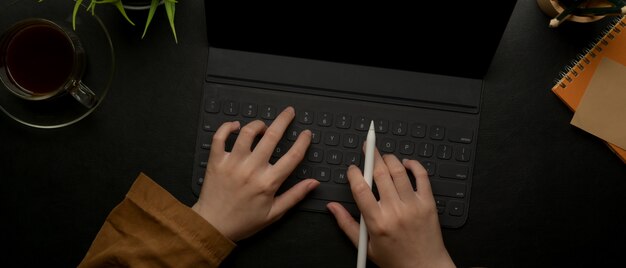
[552,17,626,163]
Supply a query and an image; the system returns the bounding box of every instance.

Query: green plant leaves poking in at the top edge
[72,0,178,43]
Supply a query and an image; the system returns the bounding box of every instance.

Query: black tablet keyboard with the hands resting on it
[192,83,476,227]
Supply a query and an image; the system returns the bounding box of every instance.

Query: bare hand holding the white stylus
[328,151,455,267]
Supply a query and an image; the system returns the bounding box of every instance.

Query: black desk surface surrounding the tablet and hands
[0,1,626,267]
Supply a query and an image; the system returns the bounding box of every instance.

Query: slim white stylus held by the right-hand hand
[356,120,376,268]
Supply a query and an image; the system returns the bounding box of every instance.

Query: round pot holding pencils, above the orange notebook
[537,0,626,28]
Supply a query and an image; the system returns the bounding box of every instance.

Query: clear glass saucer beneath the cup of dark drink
[0,0,115,128]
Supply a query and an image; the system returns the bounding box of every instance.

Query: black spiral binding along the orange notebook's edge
[554,16,626,88]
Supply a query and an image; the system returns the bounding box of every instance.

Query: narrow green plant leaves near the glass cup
[39,0,178,43]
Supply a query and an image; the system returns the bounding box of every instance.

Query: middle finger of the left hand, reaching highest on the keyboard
[252,107,296,162]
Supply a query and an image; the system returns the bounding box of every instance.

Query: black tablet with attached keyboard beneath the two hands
[191,1,516,228]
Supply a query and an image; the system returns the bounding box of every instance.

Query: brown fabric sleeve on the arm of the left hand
[79,173,235,267]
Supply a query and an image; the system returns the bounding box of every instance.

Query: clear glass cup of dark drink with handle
[0,18,98,108]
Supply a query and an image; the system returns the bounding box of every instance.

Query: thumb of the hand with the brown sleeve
[268,179,320,222]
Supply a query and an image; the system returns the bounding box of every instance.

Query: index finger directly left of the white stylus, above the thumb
[347,165,379,219]
